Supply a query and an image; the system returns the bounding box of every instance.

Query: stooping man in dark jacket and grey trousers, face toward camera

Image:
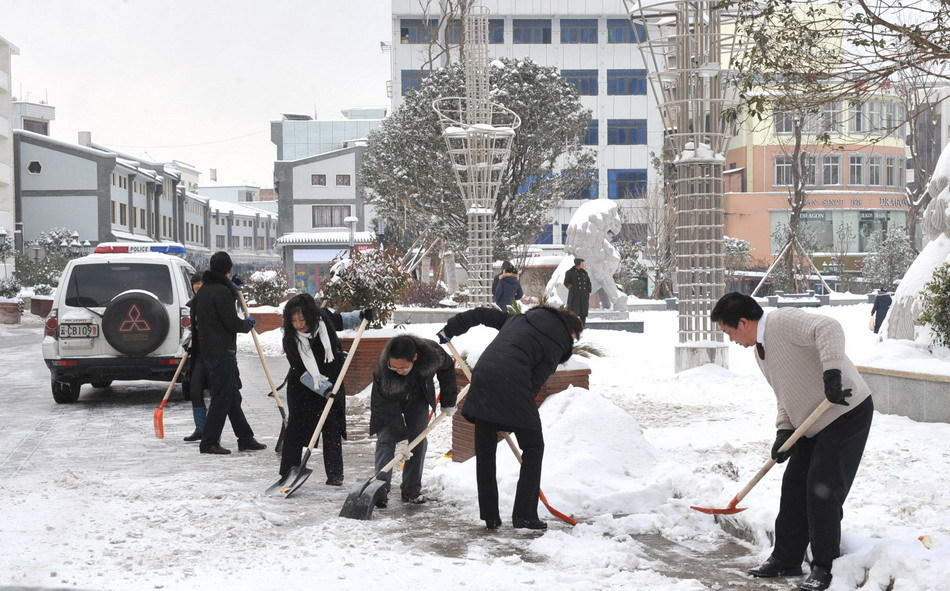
[369,334,458,507]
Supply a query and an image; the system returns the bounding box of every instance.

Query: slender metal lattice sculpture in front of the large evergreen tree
[432,6,521,305]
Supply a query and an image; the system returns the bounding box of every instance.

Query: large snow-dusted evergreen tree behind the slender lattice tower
[361,58,595,258]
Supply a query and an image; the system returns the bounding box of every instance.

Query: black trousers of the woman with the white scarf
[280,388,346,480]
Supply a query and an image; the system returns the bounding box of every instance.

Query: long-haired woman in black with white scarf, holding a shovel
[280,293,373,486]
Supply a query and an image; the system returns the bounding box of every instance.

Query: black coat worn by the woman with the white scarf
[282,310,346,445]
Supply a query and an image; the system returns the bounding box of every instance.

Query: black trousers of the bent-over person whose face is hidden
[475,419,544,521]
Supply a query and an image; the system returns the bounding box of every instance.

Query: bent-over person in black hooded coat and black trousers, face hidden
[439,306,584,529]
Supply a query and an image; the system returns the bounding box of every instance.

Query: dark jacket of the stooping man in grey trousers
[369,335,458,440]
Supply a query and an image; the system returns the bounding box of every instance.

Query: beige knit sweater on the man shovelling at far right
[752,308,871,437]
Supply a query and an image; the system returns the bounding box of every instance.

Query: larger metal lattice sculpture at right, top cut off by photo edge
[623,0,735,343]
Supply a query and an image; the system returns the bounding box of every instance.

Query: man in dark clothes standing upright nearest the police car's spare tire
[192,251,267,454]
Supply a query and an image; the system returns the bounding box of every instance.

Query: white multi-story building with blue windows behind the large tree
[391,0,662,244]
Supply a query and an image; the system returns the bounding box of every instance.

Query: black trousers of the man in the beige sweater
[772,396,874,569]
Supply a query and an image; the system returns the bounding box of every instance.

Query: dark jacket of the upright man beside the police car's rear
[191,271,251,357]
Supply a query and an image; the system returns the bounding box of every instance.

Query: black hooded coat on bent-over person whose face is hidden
[443,306,574,431]
